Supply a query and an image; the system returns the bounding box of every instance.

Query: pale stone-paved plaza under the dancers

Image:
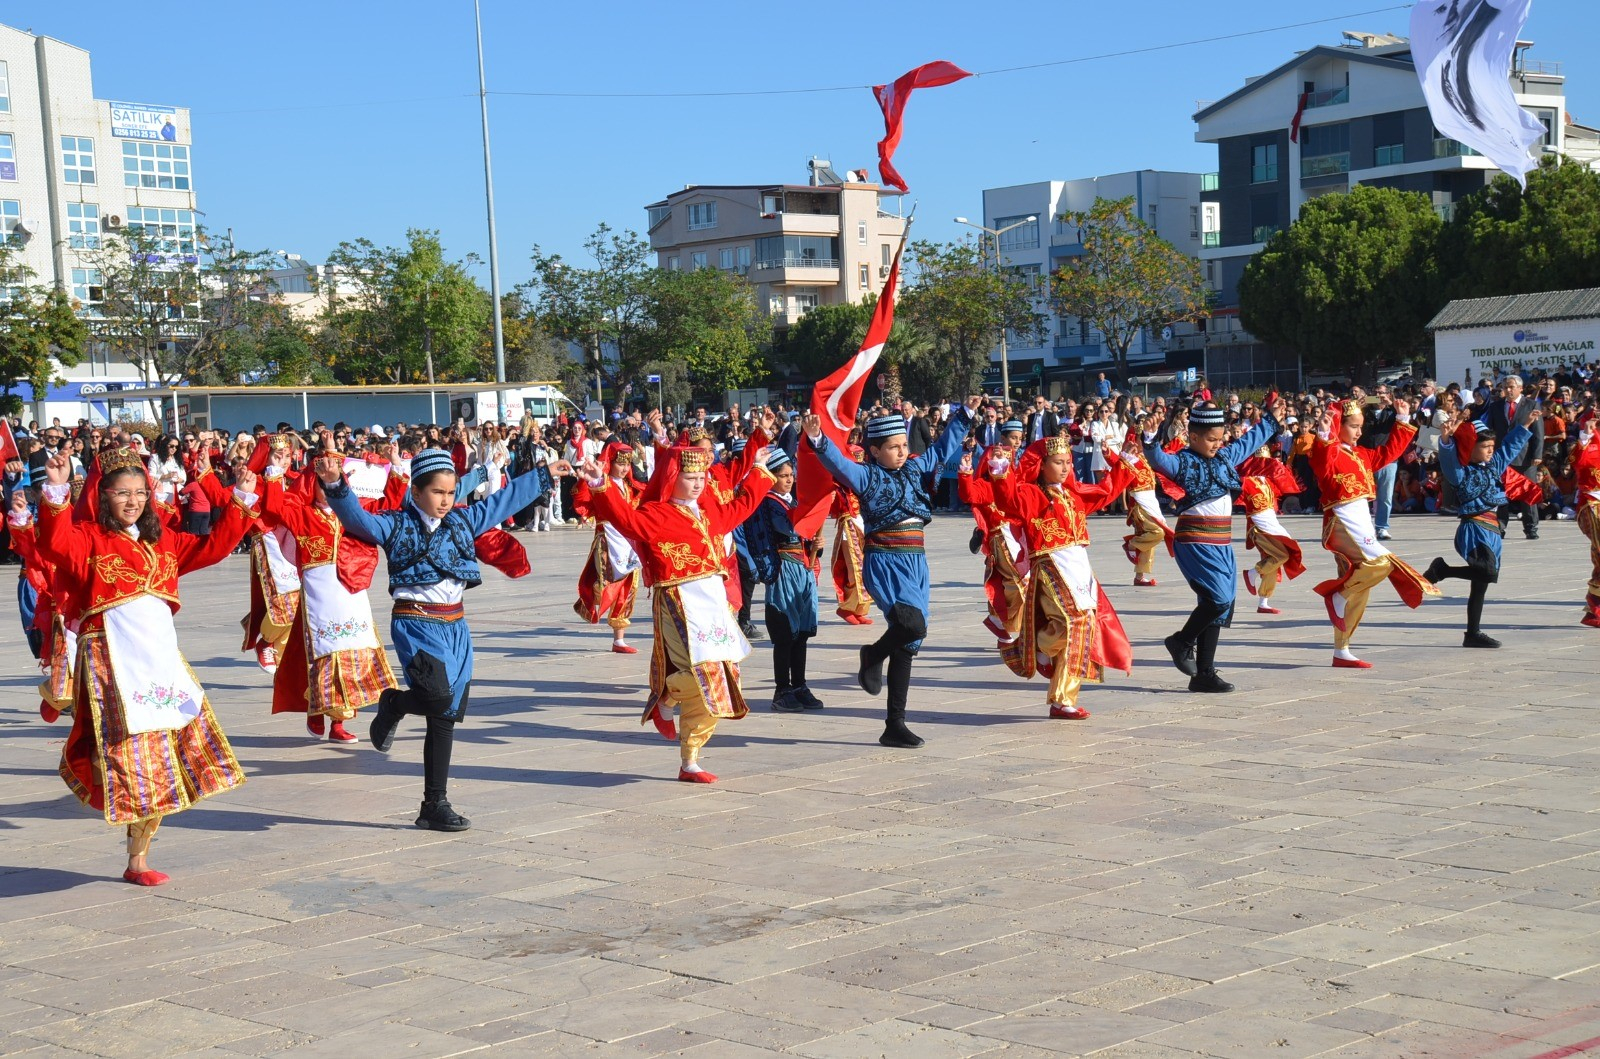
[0,517,1600,1059]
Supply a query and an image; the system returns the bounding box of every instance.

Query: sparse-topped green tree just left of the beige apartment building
[517,224,653,398]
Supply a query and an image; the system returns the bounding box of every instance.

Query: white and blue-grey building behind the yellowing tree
[982,170,1219,394]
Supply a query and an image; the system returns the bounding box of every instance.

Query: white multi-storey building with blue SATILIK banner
[0,26,197,426]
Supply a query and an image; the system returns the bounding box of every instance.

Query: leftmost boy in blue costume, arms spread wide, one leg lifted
[317,448,573,832]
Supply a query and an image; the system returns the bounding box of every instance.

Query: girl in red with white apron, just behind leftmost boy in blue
[261,458,398,742]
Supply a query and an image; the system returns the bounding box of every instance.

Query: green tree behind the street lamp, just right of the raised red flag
[898,240,1045,400]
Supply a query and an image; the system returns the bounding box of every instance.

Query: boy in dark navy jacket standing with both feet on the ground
[744,448,822,713]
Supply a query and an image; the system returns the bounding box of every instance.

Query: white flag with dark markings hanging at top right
[1411,0,1544,187]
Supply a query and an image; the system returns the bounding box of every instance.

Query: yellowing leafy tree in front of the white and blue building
[1051,197,1206,378]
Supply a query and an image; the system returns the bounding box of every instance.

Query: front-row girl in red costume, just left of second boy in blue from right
[963,437,1133,720]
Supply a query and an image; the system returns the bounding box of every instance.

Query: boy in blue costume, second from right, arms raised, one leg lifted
[1144,397,1286,694]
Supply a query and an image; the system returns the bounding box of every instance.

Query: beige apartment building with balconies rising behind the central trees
[645,158,906,330]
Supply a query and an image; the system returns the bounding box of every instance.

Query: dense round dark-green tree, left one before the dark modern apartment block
[1238,187,1442,379]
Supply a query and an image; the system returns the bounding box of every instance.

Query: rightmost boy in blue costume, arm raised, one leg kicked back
[1424,402,1544,648]
